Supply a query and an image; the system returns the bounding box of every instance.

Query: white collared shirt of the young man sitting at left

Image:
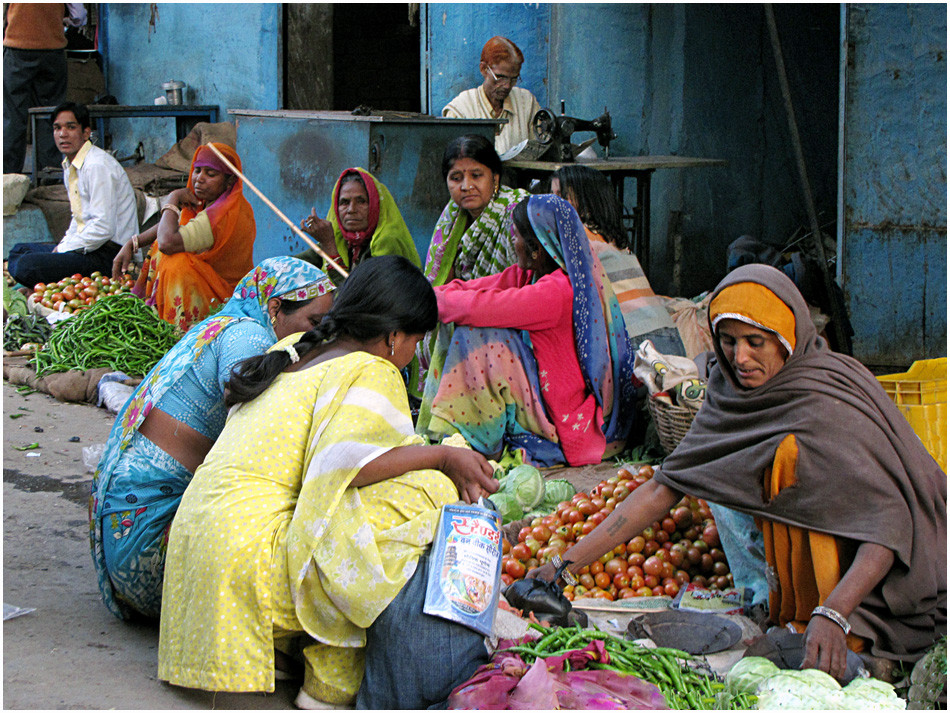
[56,141,139,253]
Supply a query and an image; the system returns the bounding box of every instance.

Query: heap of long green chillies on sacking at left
[32,294,181,376]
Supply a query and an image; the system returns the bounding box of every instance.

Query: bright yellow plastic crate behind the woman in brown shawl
[877,357,947,472]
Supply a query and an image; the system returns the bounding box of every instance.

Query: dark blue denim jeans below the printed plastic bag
[356,552,490,710]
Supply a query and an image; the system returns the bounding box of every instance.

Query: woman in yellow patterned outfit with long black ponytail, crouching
[159,256,497,705]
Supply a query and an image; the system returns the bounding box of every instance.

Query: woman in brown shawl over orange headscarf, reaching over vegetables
[538,265,947,678]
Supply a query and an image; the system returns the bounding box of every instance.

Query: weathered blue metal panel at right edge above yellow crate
[839,4,947,366]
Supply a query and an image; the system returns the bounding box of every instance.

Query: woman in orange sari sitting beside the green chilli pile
[112,143,257,330]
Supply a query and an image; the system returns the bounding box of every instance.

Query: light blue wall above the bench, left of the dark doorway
[99,3,283,162]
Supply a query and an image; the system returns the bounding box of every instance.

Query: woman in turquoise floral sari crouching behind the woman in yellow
[89,257,334,618]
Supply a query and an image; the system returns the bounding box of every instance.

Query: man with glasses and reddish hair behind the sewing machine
[442,37,541,155]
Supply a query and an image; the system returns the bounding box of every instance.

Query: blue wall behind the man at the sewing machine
[426,3,838,295]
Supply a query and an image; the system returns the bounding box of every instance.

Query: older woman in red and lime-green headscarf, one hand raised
[295,168,420,284]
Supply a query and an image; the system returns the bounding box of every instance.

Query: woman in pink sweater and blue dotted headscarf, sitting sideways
[417,195,635,466]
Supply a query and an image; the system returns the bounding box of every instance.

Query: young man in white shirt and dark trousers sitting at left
[7,102,139,287]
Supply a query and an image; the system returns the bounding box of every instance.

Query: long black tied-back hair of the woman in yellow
[225,255,439,407]
